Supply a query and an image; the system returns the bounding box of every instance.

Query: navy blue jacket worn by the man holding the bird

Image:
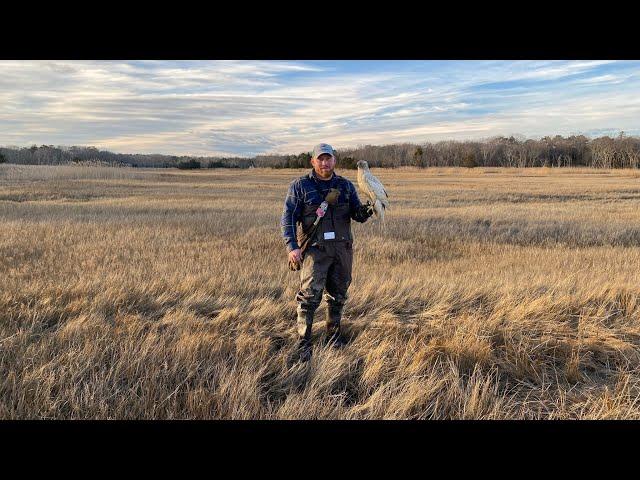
[280,170,370,251]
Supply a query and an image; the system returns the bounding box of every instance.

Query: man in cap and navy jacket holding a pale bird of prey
[280,143,373,362]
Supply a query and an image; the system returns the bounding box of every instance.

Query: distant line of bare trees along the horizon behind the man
[0,132,640,169]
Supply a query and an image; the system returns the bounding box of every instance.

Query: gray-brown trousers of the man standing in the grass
[296,242,353,339]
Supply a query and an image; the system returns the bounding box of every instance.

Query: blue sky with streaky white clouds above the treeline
[0,60,640,156]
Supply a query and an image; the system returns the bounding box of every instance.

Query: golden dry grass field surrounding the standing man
[0,165,640,419]
